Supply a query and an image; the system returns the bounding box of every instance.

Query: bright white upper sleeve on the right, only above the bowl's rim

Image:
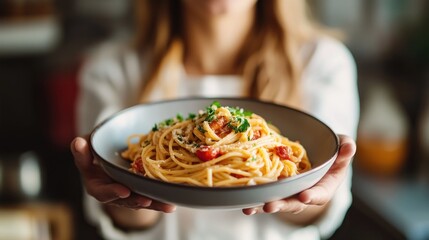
[303,38,360,138]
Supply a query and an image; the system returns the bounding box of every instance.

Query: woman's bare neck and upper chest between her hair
[184,5,254,75]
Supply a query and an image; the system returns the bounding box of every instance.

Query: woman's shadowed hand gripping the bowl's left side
[70,137,176,213]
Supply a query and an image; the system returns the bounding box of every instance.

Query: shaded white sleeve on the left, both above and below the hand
[77,45,160,240]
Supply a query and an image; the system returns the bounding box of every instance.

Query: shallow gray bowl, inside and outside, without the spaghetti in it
[90,98,339,209]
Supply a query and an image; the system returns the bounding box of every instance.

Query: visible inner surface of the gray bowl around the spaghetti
[90,98,338,173]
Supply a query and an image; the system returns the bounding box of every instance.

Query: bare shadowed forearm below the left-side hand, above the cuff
[103,204,161,230]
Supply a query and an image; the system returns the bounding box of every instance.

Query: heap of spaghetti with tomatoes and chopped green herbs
[121,101,311,187]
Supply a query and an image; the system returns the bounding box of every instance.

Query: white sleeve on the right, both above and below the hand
[304,38,359,238]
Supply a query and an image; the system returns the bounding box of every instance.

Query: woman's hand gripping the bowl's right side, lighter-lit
[243,135,356,224]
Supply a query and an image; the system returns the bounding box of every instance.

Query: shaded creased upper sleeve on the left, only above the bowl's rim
[77,44,141,134]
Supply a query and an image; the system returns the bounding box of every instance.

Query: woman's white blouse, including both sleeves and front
[77,38,359,240]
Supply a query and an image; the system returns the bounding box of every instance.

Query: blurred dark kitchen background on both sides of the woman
[0,0,429,240]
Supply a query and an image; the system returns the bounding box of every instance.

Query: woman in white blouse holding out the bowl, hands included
[71,0,359,240]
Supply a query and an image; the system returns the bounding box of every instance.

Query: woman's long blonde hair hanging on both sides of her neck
[134,0,328,107]
